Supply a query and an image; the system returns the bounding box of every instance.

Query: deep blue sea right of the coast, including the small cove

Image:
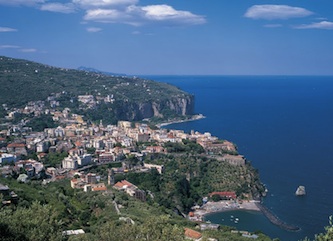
[149,76,333,241]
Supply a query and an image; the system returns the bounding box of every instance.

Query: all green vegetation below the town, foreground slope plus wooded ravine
[0,141,333,241]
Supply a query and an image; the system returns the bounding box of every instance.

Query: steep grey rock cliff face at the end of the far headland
[115,95,194,121]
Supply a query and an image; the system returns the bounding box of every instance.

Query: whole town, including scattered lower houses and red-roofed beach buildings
[0,96,264,240]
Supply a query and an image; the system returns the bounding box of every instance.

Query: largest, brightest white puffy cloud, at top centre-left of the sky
[84,4,206,25]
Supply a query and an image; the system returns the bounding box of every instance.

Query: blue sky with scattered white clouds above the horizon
[0,0,333,75]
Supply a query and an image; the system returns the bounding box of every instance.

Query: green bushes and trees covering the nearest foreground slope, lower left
[0,178,270,241]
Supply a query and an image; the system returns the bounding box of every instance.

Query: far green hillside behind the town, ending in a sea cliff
[0,56,194,123]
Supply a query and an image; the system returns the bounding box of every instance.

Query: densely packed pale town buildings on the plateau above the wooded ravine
[0,96,245,184]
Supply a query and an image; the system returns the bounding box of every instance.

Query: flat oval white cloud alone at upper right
[244,4,313,20]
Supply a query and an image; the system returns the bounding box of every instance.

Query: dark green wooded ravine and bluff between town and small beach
[120,155,264,214]
